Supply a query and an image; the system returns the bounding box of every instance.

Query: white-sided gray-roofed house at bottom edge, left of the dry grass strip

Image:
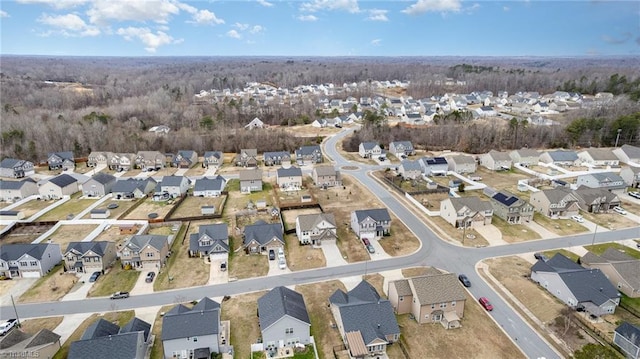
[161,297,226,359]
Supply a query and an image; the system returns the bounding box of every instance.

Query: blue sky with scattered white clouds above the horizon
[0,0,640,56]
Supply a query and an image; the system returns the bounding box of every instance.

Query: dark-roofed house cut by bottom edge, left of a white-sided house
[67,317,151,359]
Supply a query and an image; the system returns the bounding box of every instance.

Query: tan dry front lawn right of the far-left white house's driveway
[17,264,78,303]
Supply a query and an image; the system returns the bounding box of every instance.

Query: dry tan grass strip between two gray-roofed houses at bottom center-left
[220,292,264,358]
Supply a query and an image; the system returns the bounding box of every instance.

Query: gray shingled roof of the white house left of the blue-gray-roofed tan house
[258,287,311,330]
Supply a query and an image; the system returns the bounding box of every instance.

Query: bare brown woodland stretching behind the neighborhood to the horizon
[0,56,640,161]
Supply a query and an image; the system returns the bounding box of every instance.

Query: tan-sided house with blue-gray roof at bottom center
[329,280,400,358]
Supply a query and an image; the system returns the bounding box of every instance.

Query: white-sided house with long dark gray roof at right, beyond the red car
[531,253,620,316]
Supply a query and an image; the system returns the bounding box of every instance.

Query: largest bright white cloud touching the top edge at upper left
[87,0,181,25]
